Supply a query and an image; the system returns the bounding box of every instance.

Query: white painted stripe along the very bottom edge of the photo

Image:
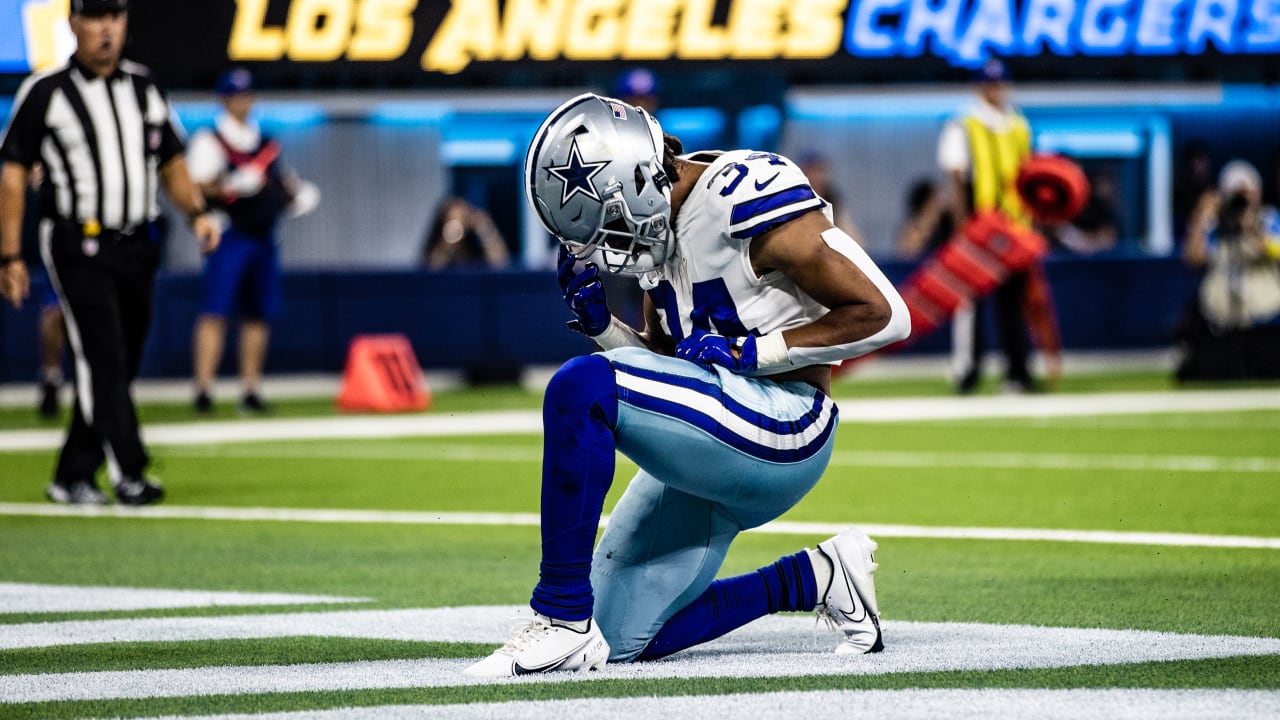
[122,688,1280,720]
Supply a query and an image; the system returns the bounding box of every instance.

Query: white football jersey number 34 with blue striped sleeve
[641,150,831,374]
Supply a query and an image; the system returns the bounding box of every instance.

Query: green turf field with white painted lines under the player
[0,373,1280,717]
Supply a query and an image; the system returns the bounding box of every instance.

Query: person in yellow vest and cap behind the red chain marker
[937,59,1060,393]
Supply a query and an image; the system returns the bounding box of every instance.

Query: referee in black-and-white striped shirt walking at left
[0,0,220,505]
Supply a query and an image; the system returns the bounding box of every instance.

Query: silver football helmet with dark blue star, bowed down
[525,94,672,274]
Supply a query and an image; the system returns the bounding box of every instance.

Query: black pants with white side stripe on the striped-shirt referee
[44,223,160,483]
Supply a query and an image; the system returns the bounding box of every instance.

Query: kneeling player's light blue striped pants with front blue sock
[532,348,838,661]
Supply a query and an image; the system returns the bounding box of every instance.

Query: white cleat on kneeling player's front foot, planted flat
[462,612,609,678]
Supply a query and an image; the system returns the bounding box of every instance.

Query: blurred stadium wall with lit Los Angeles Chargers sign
[0,0,1280,382]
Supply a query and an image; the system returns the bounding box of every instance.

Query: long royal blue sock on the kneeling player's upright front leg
[530,355,618,620]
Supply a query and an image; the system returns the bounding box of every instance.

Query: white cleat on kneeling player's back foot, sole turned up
[818,528,884,655]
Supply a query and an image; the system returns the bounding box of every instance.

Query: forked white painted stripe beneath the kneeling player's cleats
[0,606,1280,702]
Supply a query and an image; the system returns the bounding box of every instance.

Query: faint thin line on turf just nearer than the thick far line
[149,442,1280,475]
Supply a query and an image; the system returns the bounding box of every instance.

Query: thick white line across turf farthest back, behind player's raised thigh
[0,389,1280,452]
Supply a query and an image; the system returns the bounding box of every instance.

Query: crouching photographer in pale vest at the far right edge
[1178,160,1280,380]
